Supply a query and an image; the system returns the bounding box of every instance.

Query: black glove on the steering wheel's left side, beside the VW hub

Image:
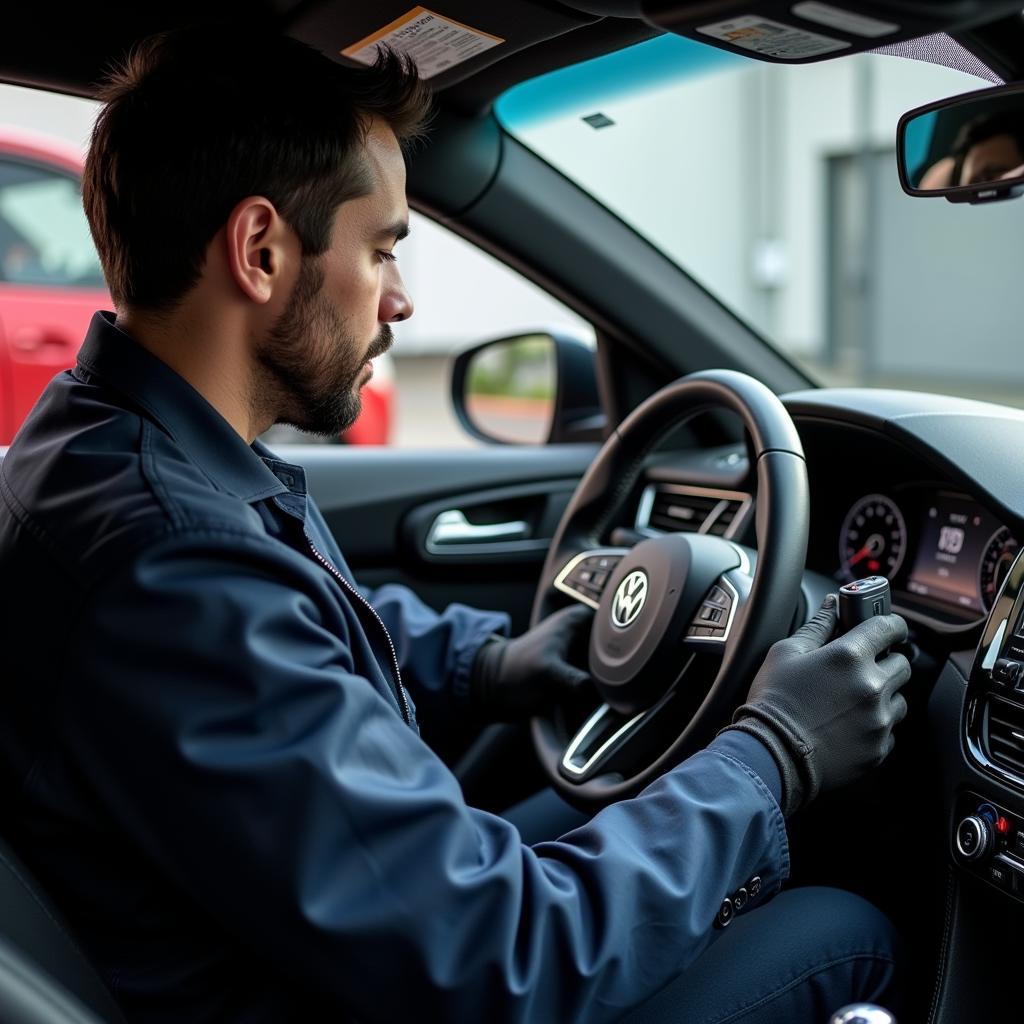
[469,604,594,720]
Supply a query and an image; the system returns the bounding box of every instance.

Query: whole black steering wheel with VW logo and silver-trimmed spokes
[530,370,809,811]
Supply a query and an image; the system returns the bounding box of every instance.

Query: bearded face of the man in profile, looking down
[256,121,413,437]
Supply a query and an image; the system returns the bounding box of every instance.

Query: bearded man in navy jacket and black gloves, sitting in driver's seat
[0,24,909,1024]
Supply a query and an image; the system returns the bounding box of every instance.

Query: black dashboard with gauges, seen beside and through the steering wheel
[637,388,1024,634]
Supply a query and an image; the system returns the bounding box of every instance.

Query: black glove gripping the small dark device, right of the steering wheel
[727,594,910,816]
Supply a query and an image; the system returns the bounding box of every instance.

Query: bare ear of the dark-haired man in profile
[225,196,291,304]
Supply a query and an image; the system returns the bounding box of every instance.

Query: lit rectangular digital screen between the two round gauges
[907,493,999,613]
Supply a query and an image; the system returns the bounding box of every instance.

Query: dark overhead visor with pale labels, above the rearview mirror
[610,0,1022,63]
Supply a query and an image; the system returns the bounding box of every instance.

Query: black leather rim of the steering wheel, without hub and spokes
[530,370,810,809]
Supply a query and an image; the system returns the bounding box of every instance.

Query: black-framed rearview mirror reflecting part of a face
[896,83,1024,203]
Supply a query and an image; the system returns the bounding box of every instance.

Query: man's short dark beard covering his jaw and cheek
[254,258,392,438]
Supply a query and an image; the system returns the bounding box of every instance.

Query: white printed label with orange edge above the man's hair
[341,7,505,78]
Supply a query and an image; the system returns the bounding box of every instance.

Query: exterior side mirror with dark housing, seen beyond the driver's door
[452,331,604,444]
